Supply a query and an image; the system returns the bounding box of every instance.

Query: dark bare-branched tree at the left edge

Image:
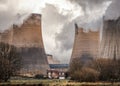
[0,43,21,81]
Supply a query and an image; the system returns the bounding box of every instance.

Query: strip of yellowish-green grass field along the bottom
[0,79,120,86]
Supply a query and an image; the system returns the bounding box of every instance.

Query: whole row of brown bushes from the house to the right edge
[69,54,120,82]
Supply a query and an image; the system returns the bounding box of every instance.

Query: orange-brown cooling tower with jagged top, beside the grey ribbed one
[70,24,99,62]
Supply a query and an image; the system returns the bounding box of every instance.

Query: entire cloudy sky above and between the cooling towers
[0,0,120,63]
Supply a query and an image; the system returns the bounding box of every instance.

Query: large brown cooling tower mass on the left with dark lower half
[1,14,49,75]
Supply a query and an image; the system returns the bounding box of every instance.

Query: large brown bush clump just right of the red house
[69,56,99,82]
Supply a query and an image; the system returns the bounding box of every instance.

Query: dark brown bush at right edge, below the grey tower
[94,58,120,81]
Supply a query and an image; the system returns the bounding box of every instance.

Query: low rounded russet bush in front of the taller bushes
[71,67,99,82]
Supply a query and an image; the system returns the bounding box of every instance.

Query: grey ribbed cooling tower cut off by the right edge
[100,17,120,59]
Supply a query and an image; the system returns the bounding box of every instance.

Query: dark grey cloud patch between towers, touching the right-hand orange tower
[55,22,74,51]
